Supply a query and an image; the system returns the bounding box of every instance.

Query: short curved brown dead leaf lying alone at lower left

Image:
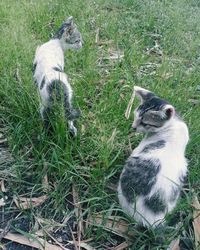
[13,195,48,209]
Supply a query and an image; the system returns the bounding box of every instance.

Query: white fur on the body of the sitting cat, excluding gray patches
[118,116,189,227]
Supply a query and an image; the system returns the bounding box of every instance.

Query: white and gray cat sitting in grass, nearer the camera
[118,86,189,227]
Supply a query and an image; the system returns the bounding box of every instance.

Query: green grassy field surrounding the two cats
[0,0,200,250]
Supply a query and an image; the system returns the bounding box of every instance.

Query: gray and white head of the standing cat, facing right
[53,16,83,49]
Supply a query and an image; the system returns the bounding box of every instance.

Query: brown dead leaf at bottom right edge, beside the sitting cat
[192,195,200,248]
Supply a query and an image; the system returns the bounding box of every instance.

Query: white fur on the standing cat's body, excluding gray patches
[33,36,82,136]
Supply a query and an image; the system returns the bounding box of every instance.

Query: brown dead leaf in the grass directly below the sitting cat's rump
[87,213,135,238]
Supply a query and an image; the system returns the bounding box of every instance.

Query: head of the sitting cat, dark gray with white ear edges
[132,86,175,133]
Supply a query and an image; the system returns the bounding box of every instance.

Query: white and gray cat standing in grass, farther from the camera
[33,17,82,136]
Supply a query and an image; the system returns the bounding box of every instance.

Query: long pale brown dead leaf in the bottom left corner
[4,233,69,250]
